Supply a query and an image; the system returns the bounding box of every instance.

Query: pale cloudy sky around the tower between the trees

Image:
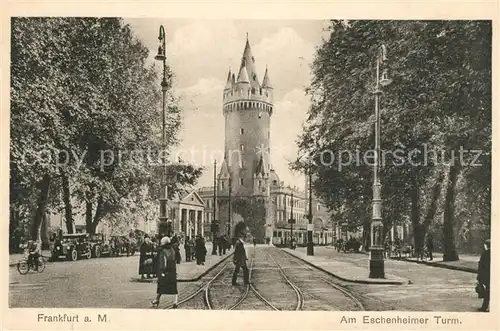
[125,18,327,187]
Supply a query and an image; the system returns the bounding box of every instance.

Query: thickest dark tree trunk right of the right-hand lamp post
[443,165,460,261]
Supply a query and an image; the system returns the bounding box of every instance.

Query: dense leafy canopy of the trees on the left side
[10,18,201,249]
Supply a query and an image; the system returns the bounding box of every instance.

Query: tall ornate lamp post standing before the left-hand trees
[155,25,172,237]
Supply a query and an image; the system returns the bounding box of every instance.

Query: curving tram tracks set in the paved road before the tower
[165,249,365,311]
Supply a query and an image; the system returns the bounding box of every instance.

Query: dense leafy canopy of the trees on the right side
[292,20,492,260]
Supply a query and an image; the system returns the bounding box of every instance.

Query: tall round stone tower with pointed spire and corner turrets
[218,36,273,239]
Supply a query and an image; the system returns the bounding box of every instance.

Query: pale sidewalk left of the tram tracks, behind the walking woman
[132,243,234,283]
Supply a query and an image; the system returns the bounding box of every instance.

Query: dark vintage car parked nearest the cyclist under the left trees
[52,233,92,261]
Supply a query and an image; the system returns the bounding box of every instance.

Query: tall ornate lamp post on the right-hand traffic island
[369,45,391,278]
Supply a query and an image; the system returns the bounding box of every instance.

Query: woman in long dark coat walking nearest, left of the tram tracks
[151,237,178,308]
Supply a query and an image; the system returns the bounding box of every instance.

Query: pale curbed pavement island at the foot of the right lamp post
[282,247,408,285]
